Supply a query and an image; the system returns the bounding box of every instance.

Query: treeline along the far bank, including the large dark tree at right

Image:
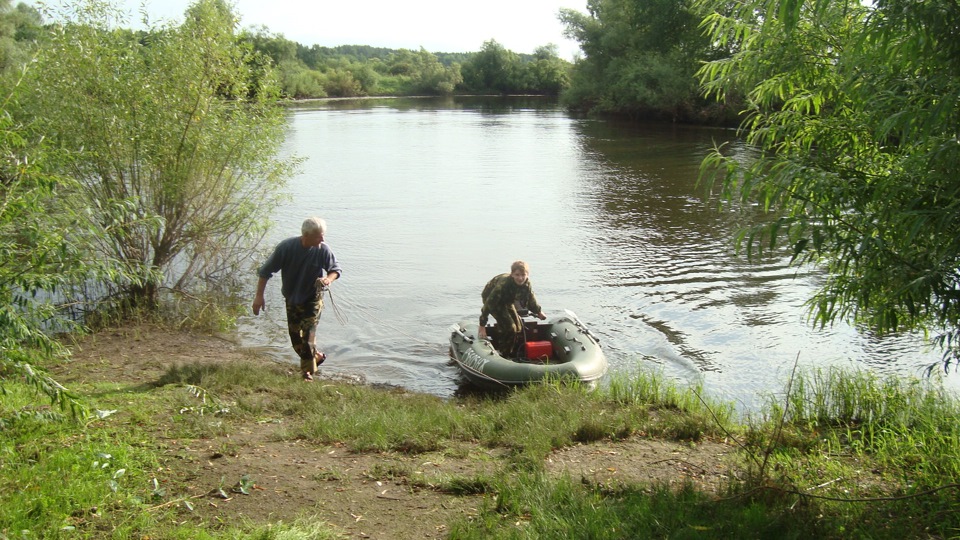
[0,0,744,124]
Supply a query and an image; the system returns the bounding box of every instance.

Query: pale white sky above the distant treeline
[27,0,587,60]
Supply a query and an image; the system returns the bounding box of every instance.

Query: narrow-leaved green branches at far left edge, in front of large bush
[0,83,97,418]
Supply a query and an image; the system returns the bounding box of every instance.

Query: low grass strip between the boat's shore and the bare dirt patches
[292,375,732,469]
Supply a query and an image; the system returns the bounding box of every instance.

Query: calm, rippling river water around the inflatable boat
[234,98,960,410]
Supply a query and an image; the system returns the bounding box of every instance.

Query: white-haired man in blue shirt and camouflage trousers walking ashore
[253,217,341,382]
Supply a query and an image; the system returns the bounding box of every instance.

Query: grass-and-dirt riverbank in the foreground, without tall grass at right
[0,323,957,539]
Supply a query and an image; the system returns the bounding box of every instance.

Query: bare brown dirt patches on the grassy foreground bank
[53,326,733,539]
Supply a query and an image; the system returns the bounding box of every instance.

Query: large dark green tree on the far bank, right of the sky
[560,0,736,123]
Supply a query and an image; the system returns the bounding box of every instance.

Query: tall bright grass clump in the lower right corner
[712,369,960,538]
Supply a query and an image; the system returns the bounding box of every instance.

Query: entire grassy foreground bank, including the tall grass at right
[0,326,960,538]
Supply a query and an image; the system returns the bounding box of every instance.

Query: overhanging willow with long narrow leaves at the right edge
[701,0,960,366]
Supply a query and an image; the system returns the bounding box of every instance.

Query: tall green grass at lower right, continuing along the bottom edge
[450,371,960,539]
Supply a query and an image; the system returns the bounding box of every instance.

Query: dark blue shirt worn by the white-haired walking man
[257,236,343,305]
